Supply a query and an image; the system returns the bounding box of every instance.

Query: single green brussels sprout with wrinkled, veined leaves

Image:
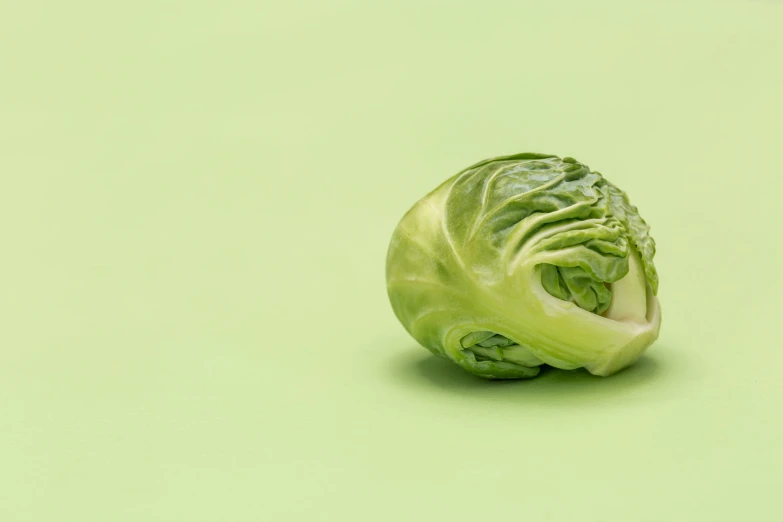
[386,153,661,379]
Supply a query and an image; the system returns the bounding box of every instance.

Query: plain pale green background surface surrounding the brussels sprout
[0,0,783,522]
